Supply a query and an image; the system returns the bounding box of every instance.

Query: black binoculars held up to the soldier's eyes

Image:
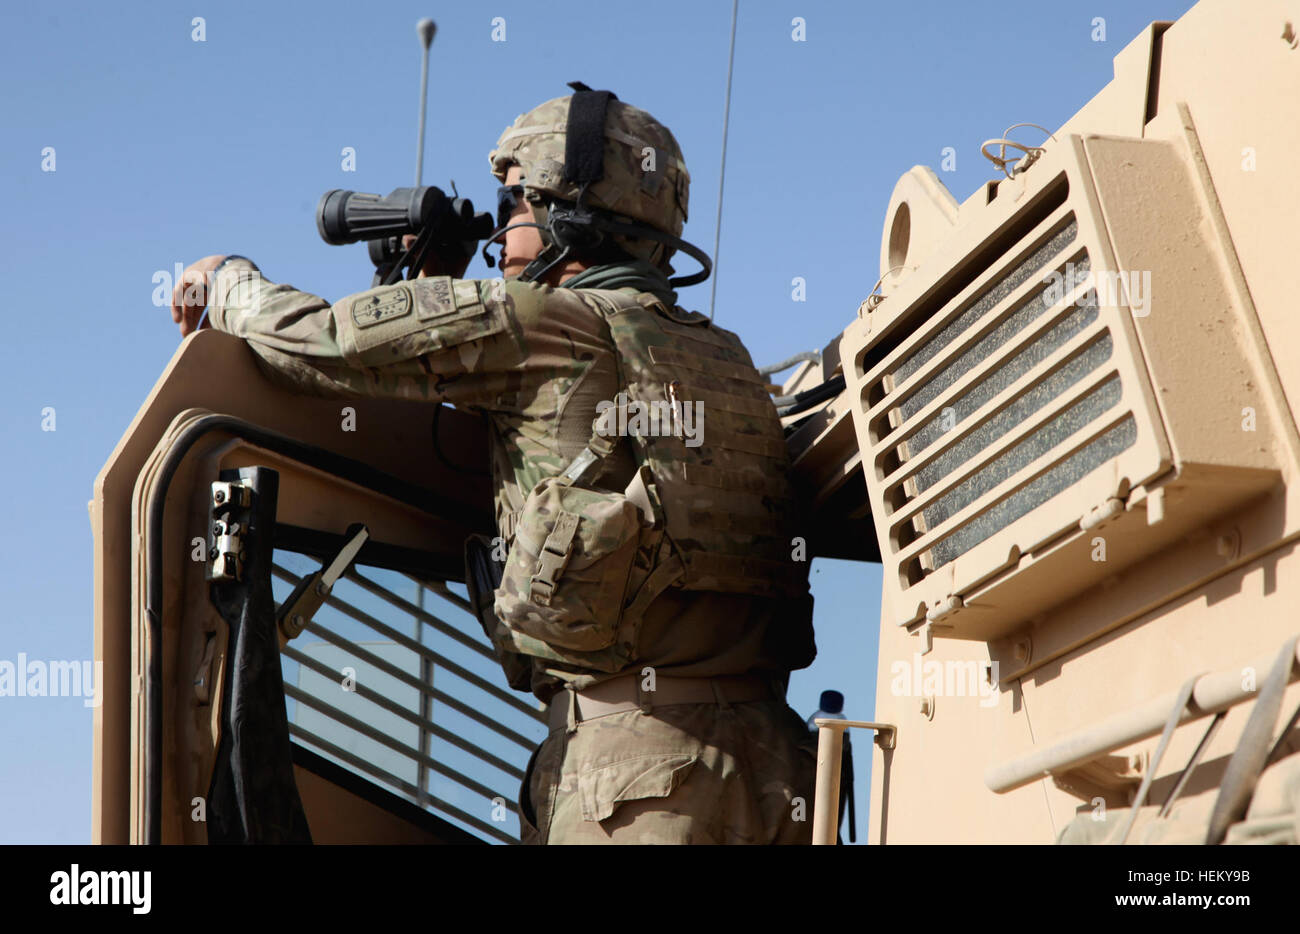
[316,185,494,284]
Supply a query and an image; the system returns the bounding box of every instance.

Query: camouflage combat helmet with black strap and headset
[488,82,711,285]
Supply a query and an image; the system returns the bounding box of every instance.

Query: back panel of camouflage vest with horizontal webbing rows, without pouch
[593,290,807,597]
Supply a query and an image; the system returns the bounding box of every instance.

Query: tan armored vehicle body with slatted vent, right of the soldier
[787,0,1300,843]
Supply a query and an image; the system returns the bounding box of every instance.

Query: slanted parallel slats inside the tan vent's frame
[865,195,1136,600]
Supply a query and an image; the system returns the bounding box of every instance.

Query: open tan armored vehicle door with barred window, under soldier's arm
[90,330,545,843]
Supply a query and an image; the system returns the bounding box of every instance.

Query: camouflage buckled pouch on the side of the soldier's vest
[494,480,641,652]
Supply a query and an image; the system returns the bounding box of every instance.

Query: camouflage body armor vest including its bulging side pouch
[486,289,811,687]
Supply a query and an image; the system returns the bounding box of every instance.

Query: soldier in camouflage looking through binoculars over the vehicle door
[172,88,815,843]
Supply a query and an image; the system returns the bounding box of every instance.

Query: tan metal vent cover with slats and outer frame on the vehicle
[841,138,1227,637]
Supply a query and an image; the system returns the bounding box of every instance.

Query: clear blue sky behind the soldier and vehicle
[0,0,1192,843]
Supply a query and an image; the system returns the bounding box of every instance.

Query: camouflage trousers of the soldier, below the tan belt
[520,695,816,844]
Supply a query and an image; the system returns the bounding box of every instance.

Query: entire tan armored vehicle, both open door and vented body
[91,0,1300,843]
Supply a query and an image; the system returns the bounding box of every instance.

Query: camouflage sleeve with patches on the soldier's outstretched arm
[209,259,561,410]
